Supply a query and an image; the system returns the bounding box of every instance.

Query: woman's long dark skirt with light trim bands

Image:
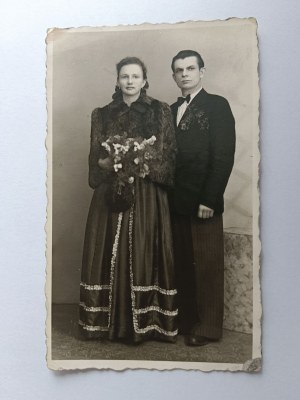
[79,179,177,342]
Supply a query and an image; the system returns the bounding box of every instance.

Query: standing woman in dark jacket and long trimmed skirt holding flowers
[79,57,177,343]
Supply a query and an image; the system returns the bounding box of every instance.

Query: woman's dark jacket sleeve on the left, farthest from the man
[89,108,109,189]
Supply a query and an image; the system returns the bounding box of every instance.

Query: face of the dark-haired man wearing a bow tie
[173,56,203,95]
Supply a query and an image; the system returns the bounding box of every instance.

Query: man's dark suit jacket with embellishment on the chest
[170,89,235,215]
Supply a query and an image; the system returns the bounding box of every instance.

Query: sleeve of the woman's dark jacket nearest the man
[149,102,176,186]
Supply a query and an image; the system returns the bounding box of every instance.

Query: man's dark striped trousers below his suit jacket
[172,215,224,339]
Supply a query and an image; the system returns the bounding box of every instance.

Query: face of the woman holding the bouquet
[117,64,146,96]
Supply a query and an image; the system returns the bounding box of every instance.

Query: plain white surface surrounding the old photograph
[0,0,300,400]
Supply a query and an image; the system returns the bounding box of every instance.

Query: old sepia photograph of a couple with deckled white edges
[46,18,262,372]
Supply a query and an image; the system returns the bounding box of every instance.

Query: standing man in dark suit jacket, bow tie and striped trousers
[170,50,235,346]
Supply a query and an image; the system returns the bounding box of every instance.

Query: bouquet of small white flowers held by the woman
[101,135,156,212]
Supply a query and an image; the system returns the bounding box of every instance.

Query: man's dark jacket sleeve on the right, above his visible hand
[200,97,235,209]
